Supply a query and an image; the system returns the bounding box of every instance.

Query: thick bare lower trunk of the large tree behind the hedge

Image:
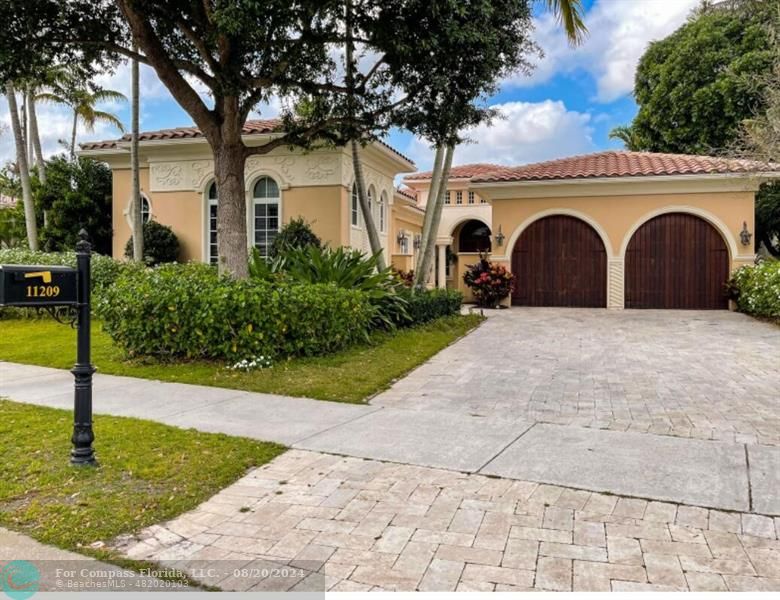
[212,141,249,279]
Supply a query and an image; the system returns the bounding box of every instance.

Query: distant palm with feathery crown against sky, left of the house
[38,80,127,160]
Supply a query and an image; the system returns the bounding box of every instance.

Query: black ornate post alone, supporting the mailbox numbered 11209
[70,229,95,465]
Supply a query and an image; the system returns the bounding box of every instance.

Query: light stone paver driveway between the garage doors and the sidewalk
[371,308,780,446]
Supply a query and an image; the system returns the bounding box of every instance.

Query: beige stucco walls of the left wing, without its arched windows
[81,135,414,261]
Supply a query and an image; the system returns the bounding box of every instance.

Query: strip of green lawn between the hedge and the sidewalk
[0,315,482,403]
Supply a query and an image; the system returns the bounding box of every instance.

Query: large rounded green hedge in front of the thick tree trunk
[97,263,374,361]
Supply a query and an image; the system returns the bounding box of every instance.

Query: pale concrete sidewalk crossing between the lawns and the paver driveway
[0,362,780,515]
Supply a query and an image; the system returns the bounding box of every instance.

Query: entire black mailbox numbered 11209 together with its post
[0,229,96,465]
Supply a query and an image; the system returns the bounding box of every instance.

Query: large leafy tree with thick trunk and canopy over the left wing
[0,0,544,276]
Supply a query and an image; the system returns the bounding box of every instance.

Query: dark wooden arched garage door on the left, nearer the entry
[512,215,607,307]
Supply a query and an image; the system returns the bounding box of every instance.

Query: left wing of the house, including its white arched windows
[80,119,423,268]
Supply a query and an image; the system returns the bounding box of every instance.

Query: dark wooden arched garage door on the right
[625,213,729,309]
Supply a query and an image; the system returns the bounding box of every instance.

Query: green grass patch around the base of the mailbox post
[0,399,284,567]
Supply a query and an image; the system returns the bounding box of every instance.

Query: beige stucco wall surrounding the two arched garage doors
[405,175,761,308]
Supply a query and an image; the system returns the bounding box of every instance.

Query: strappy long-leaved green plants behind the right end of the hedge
[249,246,408,329]
